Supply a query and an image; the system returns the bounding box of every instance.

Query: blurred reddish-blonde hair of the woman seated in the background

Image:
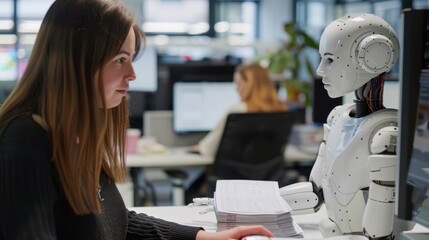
[236,63,287,112]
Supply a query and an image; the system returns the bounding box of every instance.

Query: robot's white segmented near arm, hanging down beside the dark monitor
[362,126,413,239]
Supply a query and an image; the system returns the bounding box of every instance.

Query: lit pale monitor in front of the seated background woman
[173,82,240,134]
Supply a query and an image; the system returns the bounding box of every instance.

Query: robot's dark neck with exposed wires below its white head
[354,73,386,118]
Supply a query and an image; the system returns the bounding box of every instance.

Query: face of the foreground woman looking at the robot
[95,28,136,108]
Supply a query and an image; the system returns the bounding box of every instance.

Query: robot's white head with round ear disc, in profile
[317,13,399,98]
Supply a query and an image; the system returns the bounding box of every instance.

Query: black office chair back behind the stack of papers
[208,112,295,195]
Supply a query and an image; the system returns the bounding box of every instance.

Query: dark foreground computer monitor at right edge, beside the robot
[395,10,429,227]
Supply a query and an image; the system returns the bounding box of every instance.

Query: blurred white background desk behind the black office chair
[127,145,317,167]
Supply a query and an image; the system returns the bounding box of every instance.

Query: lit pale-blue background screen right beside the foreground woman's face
[129,46,158,92]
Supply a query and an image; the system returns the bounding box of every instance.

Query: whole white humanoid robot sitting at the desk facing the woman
[280,14,411,239]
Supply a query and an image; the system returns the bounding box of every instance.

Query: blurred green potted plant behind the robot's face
[256,22,319,106]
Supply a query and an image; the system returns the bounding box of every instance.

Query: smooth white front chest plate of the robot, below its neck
[324,110,371,199]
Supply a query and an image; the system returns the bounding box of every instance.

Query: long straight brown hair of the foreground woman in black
[0,0,144,214]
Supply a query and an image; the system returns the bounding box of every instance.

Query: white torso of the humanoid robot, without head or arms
[320,104,397,233]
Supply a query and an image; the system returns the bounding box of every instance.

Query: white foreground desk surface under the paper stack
[130,205,429,240]
